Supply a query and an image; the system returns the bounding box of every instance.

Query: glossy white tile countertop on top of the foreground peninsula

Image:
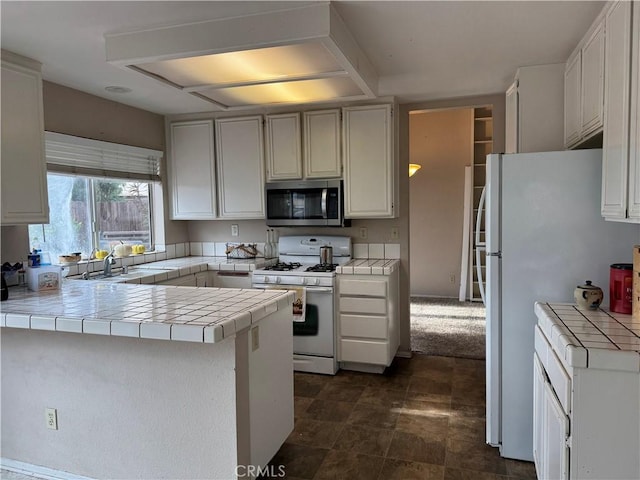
[0,280,293,343]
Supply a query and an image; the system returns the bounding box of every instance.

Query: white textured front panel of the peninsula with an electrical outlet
[1,328,237,479]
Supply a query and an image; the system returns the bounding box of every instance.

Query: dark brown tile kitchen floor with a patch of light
[265,355,536,480]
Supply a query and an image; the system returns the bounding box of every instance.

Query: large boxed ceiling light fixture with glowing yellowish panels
[105,3,377,110]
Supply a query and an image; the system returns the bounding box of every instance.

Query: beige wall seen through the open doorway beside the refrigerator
[409,108,473,297]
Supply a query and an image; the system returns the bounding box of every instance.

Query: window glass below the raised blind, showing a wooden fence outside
[29,173,152,258]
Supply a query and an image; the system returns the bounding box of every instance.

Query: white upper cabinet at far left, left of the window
[1,51,49,225]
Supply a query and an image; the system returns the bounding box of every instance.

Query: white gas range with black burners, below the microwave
[252,235,351,375]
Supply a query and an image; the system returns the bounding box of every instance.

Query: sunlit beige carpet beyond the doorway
[411,297,486,359]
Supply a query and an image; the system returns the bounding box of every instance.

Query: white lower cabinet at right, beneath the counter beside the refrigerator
[533,317,640,480]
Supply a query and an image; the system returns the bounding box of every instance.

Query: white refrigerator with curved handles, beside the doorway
[476,150,640,461]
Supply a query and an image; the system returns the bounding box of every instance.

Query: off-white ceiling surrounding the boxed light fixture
[0,0,604,114]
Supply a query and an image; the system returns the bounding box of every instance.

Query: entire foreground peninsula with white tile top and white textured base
[0,280,293,479]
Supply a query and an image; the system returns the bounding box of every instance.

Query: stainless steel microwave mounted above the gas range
[266,180,350,227]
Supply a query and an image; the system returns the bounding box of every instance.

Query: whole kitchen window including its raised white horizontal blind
[29,132,162,261]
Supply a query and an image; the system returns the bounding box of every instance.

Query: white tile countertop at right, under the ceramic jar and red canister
[534,302,640,372]
